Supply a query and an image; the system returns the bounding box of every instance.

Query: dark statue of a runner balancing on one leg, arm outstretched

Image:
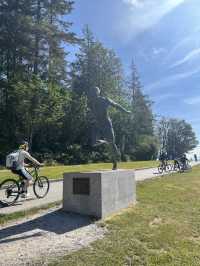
[89,87,131,170]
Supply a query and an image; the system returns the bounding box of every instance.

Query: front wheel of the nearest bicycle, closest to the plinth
[33,176,49,198]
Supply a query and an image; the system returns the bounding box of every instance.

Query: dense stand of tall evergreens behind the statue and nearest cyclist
[0,0,197,164]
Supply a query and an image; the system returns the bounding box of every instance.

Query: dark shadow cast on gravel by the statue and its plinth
[0,209,93,245]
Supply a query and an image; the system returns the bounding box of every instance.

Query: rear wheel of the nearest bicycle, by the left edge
[0,179,20,206]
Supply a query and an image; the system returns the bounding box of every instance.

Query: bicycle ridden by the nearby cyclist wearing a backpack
[0,166,50,206]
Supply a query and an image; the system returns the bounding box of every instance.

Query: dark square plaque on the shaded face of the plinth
[73,178,90,195]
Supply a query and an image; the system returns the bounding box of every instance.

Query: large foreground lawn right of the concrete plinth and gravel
[50,166,200,266]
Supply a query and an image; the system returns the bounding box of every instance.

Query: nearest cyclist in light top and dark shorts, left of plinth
[11,141,43,198]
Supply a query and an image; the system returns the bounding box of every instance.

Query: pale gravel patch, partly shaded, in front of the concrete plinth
[0,207,106,266]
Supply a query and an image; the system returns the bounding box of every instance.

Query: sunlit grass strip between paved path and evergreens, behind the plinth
[0,161,158,181]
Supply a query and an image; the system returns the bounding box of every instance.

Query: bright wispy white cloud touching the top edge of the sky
[120,0,186,38]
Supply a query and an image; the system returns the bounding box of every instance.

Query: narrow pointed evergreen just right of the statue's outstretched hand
[123,62,157,159]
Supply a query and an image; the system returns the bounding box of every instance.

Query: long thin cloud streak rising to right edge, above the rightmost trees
[144,68,200,92]
